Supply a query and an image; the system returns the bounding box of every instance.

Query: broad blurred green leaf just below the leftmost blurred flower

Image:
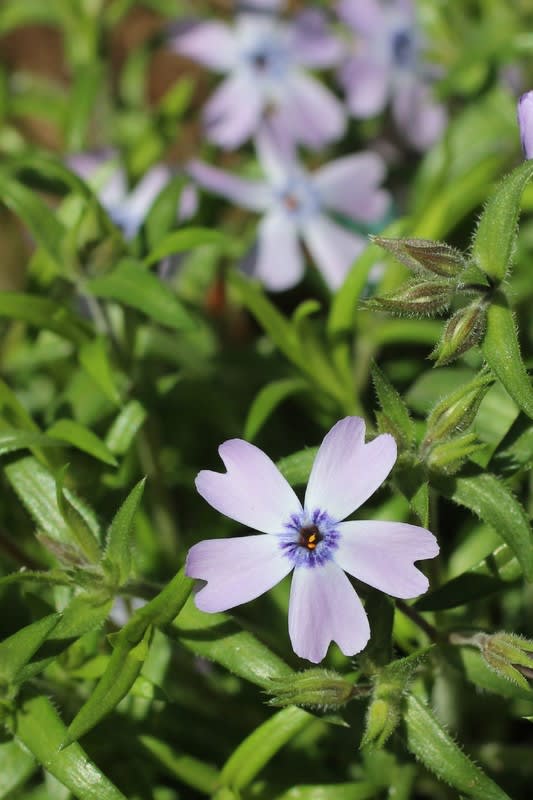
[87,260,195,331]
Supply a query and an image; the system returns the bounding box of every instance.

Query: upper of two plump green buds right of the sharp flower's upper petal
[422,370,494,450]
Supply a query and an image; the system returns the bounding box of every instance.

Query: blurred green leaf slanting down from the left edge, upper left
[0,171,65,266]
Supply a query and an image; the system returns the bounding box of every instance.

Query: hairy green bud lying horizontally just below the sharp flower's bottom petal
[268,669,357,709]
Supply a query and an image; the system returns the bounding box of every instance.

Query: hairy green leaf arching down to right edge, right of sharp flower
[433,473,533,581]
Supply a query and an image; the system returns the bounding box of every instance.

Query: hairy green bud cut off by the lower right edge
[474,631,533,689]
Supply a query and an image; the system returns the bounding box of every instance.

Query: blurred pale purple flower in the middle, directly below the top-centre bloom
[189,137,390,291]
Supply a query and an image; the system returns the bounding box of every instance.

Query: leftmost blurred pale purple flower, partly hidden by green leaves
[68,152,197,239]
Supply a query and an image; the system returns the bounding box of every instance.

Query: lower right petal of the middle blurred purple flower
[302,214,367,291]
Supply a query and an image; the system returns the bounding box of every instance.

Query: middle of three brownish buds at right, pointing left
[367,281,455,316]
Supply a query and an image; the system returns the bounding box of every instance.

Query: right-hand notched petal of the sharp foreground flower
[334,521,439,598]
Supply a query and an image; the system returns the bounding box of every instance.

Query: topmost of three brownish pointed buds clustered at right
[371,236,466,278]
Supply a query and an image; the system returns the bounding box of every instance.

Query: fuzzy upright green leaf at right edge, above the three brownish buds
[472,161,533,283]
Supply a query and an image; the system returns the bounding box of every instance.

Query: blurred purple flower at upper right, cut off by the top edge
[337,0,447,150]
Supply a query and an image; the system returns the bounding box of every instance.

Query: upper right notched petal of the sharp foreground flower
[304,417,396,520]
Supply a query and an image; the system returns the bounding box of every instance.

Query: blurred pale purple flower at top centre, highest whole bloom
[170,10,345,150]
